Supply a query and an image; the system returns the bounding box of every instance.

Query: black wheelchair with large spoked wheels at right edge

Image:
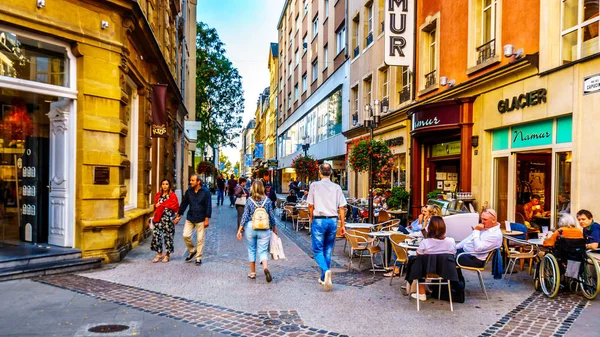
[534,237,600,300]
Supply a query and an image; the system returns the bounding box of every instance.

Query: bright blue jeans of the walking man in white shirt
[312,218,337,280]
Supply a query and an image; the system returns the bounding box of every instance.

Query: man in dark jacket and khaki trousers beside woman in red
[174,174,212,266]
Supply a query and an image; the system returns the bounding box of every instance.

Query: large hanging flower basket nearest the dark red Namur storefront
[349,140,394,178]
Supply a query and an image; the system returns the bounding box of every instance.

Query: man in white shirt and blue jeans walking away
[307,163,346,291]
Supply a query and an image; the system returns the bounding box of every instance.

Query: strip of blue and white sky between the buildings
[197,0,285,164]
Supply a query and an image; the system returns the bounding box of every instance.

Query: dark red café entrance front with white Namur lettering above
[409,98,474,216]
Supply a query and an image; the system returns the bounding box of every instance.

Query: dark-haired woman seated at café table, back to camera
[406,216,456,301]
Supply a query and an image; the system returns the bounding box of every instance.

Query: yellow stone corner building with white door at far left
[0,0,196,262]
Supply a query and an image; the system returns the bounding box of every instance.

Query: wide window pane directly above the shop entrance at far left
[0,31,69,87]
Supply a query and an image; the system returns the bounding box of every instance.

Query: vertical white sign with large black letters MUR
[384,0,415,69]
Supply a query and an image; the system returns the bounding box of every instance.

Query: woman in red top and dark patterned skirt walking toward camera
[150,179,179,263]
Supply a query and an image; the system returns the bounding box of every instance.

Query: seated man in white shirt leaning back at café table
[456,209,502,268]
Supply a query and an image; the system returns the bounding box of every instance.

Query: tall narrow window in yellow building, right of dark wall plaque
[123,81,139,211]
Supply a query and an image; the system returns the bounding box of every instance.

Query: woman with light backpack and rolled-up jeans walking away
[237,180,277,282]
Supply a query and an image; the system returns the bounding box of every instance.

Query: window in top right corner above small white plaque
[561,0,600,64]
